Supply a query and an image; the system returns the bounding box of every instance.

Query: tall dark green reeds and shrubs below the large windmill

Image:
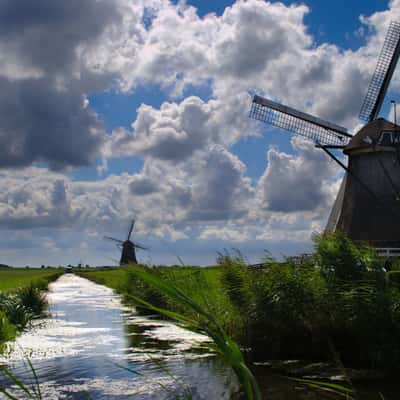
[220,233,400,369]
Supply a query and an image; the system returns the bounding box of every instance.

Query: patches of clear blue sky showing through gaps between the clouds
[85,0,394,183]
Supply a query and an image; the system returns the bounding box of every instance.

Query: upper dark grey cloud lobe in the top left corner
[0,0,120,77]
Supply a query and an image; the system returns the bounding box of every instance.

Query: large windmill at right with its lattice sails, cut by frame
[250,22,400,255]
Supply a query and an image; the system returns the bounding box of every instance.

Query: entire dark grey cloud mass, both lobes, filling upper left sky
[0,0,121,169]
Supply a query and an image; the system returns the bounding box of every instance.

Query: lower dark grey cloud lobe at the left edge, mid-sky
[0,78,102,169]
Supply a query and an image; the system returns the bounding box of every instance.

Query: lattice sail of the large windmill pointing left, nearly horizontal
[250,95,352,147]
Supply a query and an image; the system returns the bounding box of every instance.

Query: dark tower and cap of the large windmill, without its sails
[336,119,400,249]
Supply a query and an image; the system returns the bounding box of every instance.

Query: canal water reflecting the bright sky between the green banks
[0,274,400,400]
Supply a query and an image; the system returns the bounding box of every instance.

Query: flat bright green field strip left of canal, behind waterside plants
[0,268,62,292]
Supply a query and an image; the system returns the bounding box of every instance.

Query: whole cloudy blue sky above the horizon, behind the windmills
[0,0,400,266]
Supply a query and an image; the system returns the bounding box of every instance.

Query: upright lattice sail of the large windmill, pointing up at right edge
[359,22,400,122]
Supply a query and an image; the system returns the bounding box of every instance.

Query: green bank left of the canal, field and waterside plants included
[0,268,63,351]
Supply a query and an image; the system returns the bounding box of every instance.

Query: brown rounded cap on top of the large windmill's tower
[343,118,400,154]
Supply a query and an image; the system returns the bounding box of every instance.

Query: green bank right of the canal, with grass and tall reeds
[82,234,400,371]
